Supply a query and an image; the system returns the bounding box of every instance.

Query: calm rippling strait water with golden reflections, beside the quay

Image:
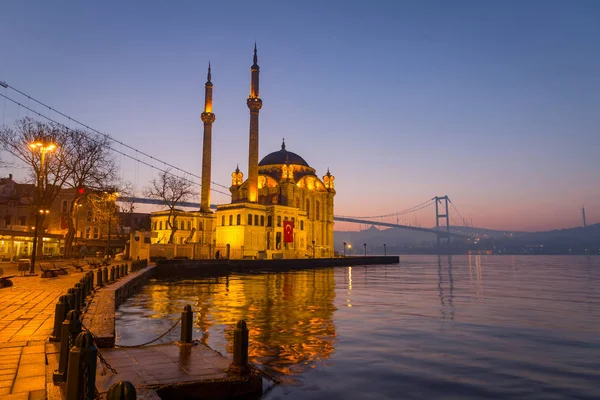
[117,256,600,400]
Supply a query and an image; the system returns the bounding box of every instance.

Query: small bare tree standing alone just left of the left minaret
[144,170,194,243]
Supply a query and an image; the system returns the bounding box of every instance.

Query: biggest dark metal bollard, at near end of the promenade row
[66,332,98,400]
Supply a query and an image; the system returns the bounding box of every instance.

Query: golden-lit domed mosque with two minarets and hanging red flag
[151,45,335,259]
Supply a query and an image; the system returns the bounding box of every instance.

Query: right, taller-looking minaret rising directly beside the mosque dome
[246,43,262,203]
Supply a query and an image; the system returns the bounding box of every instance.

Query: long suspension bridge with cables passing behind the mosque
[0,81,470,241]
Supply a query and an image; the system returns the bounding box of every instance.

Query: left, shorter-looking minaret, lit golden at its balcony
[200,63,215,213]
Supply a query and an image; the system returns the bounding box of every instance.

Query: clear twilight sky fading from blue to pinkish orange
[0,0,600,230]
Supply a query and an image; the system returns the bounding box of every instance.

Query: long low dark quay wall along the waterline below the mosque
[154,256,400,278]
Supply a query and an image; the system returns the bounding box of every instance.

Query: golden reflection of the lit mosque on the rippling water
[141,269,338,375]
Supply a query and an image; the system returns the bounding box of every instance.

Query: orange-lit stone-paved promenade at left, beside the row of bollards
[0,262,98,400]
